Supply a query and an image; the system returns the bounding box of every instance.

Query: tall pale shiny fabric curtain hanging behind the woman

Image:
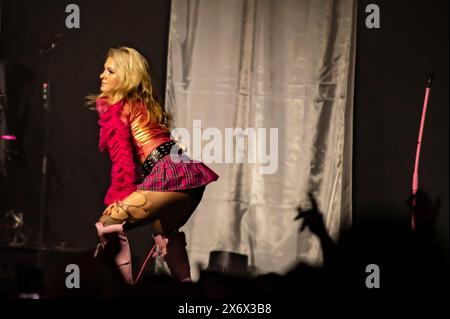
[166,0,356,279]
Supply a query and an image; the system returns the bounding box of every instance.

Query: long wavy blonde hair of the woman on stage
[88,46,172,129]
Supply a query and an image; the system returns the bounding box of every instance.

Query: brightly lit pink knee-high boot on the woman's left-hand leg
[94,222,134,285]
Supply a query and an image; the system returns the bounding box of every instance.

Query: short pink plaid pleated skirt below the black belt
[137,154,219,192]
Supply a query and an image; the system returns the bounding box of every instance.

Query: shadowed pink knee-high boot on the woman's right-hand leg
[164,231,191,281]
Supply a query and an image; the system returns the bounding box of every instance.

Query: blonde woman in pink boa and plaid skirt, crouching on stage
[90,47,218,284]
